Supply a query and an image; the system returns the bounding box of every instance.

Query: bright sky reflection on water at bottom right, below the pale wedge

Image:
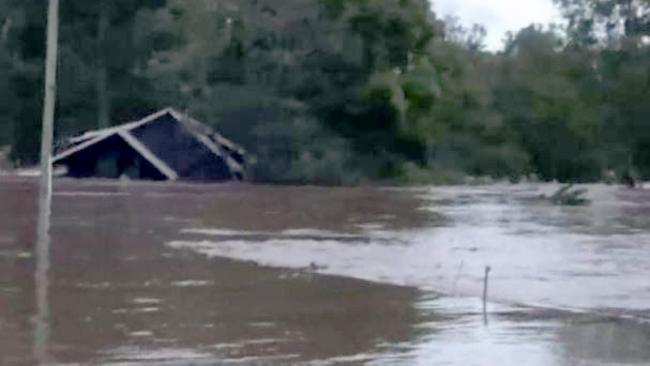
[368,295,650,366]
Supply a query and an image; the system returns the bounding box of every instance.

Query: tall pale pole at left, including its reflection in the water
[34,0,59,364]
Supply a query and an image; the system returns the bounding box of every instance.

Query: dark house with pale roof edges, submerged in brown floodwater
[52,108,246,181]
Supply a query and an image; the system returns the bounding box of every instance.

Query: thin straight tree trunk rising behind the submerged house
[96,0,111,128]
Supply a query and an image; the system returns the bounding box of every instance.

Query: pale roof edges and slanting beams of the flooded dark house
[52,107,246,180]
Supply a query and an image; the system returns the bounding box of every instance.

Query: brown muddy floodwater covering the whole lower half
[0,177,650,366]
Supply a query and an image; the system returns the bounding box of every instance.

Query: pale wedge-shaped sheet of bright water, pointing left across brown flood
[168,186,650,316]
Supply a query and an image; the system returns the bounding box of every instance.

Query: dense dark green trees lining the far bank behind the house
[0,0,650,184]
